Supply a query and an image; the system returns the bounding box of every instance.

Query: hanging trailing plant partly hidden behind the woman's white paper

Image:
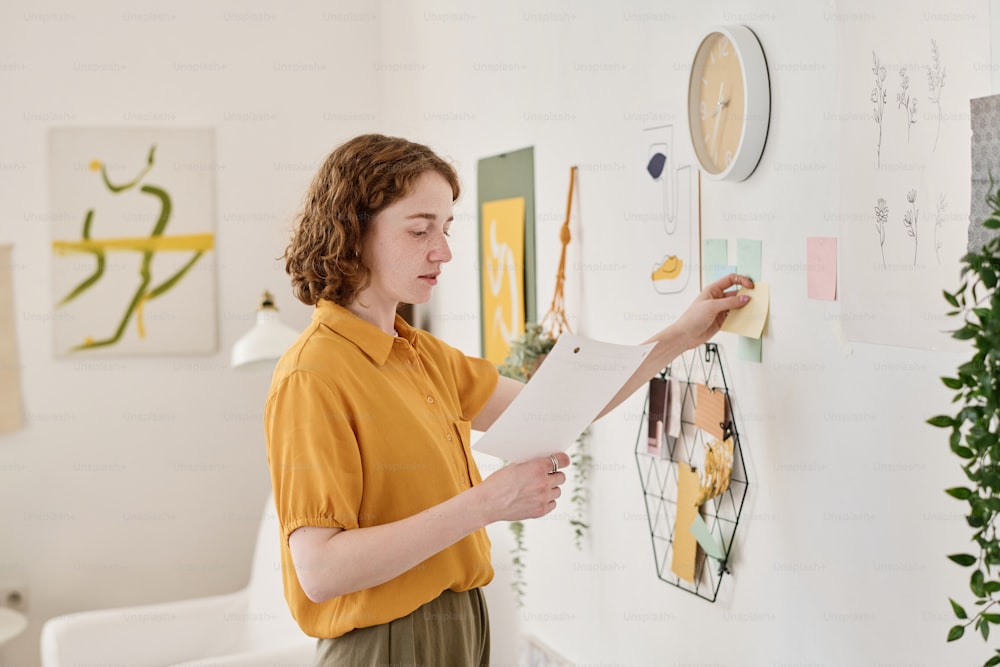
[499,322,592,607]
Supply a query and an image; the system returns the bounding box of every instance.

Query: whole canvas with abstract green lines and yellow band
[48,128,221,357]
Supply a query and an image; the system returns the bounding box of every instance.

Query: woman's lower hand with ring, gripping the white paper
[477,452,569,523]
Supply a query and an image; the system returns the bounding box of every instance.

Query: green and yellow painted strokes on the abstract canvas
[52,144,213,352]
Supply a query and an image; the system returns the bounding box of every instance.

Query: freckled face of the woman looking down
[358,171,453,310]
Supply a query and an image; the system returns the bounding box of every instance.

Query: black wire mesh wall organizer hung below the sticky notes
[635,343,749,602]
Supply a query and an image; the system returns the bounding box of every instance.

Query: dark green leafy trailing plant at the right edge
[927,177,1000,667]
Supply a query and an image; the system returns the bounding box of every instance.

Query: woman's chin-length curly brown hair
[283,134,461,306]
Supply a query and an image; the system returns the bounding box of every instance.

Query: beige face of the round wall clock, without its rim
[688,32,746,174]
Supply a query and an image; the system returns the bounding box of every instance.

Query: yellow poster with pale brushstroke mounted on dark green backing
[480,197,525,365]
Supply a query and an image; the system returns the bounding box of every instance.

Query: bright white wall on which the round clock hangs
[384,0,989,667]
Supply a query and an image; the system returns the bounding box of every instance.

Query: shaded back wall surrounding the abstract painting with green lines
[0,2,380,667]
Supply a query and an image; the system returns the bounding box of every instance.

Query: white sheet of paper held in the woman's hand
[473,333,655,462]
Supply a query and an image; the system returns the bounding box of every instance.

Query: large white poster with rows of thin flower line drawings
[836,0,984,350]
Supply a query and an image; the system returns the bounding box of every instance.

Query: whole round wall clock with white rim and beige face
[688,25,771,181]
